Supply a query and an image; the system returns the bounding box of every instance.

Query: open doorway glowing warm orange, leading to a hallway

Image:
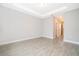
[53,16,64,41]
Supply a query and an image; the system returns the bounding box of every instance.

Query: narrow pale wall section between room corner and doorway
[43,17,53,39]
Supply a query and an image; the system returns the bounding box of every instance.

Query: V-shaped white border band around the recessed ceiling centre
[1,3,79,18]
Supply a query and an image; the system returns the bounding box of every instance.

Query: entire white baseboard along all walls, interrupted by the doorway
[0,36,79,45]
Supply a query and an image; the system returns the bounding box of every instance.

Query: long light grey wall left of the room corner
[0,6,42,44]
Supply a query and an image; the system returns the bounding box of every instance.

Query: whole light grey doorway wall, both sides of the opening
[43,9,79,42]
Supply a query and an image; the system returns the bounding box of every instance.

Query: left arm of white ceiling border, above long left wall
[1,3,42,18]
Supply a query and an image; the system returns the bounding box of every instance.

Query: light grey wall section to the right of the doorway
[63,9,79,42]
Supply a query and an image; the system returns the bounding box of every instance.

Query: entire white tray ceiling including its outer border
[2,3,79,18]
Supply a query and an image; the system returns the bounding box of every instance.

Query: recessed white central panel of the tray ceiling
[20,3,66,15]
